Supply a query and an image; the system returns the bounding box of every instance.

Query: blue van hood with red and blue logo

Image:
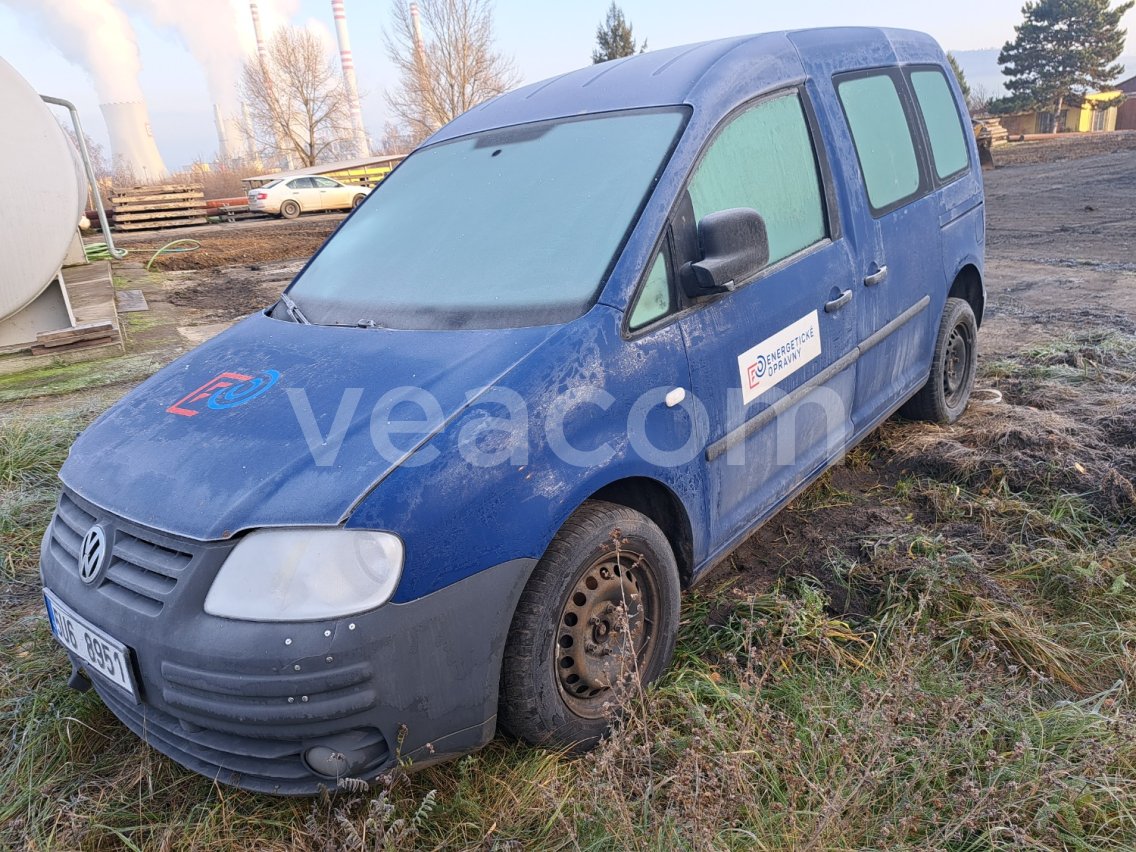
[59,314,557,541]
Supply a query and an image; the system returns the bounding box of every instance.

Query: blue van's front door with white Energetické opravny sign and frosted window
[670,90,857,549]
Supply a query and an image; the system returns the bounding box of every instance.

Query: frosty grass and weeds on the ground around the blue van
[0,334,1136,850]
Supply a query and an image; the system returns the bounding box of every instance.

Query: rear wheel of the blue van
[900,298,978,424]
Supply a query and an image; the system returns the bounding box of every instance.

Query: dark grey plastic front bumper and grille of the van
[41,493,535,795]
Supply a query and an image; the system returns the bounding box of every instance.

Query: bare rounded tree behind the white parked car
[241,27,353,166]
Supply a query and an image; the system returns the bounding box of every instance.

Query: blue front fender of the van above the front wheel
[348,306,708,602]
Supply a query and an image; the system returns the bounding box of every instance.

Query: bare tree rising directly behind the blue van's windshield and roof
[385,0,519,144]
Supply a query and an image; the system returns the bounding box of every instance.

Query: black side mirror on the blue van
[682,207,769,299]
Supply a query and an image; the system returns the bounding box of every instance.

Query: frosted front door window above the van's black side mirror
[688,93,827,264]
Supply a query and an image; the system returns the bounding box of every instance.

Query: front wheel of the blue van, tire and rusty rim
[498,501,682,751]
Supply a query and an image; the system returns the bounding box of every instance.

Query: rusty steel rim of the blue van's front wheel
[553,549,661,719]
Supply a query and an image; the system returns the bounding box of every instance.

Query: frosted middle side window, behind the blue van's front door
[836,73,919,211]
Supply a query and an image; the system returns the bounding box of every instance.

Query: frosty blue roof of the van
[428,27,943,142]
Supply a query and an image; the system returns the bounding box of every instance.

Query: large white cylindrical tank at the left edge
[0,58,86,319]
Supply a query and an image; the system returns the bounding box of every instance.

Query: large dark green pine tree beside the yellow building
[997,0,1136,133]
